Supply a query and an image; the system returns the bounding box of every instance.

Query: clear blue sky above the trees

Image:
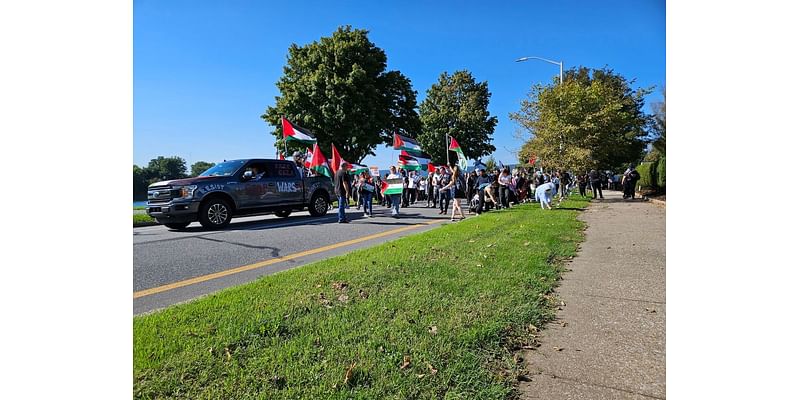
[133,0,666,169]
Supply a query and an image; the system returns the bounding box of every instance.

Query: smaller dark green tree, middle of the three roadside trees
[417,71,497,163]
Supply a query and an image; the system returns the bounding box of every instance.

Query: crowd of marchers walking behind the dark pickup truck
[288,153,639,223]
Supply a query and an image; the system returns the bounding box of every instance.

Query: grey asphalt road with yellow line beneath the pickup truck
[133,202,466,315]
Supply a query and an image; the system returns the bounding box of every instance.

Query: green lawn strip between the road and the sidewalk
[133,195,587,399]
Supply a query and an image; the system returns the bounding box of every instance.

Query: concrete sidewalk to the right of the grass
[520,191,666,399]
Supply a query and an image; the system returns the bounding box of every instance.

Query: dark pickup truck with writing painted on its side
[147,159,335,229]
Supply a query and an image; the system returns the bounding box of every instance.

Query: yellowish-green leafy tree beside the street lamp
[510,67,652,170]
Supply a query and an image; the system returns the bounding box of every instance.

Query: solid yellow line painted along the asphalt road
[133,219,444,299]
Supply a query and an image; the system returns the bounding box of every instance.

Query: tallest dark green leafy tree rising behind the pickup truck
[261,26,420,162]
